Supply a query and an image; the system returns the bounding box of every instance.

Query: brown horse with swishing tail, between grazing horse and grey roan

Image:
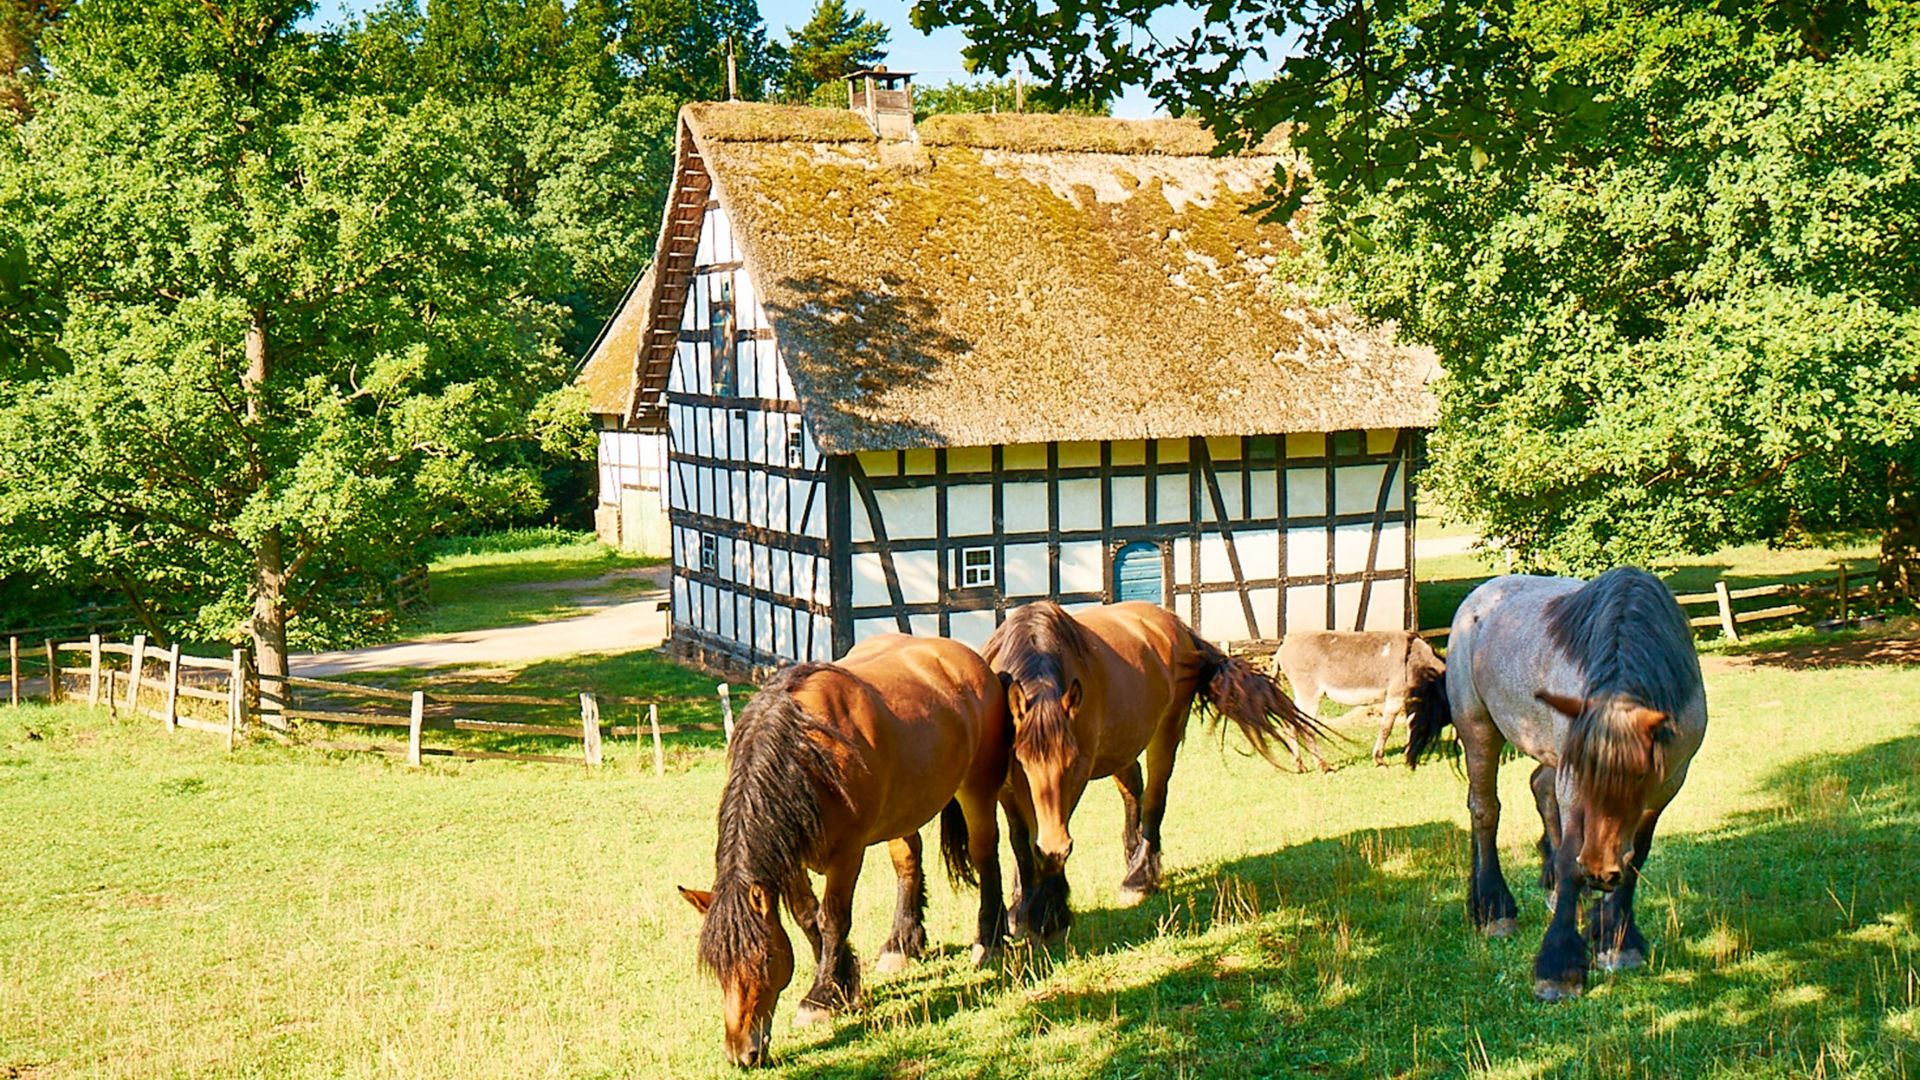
[985,601,1321,938]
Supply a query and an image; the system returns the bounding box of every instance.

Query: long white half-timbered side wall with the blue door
[831,429,1417,653]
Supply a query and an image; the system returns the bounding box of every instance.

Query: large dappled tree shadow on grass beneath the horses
[793,736,1920,1076]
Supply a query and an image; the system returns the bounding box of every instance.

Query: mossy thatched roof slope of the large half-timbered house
[625,104,1434,452]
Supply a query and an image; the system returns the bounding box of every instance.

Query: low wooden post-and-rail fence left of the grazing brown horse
[6,634,733,774]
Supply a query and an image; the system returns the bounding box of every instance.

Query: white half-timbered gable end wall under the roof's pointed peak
[666,200,835,667]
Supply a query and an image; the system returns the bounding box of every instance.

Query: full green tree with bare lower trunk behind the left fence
[0,0,566,696]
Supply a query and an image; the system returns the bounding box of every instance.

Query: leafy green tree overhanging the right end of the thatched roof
[914,0,1920,594]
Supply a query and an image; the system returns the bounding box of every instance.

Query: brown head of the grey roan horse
[1536,692,1674,892]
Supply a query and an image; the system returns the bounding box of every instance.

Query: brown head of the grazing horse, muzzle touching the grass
[680,882,793,1068]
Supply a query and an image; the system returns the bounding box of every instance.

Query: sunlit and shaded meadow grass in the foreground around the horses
[0,641,1920,1078]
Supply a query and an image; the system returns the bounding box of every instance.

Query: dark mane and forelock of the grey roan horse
[1546,567,1699,799]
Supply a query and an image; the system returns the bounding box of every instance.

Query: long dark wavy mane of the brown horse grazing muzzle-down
[699,663,847,980]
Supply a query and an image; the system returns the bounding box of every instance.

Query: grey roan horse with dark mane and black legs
[1407,567,1707,1001]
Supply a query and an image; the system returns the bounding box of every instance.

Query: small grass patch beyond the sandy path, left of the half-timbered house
[405,528,664,634]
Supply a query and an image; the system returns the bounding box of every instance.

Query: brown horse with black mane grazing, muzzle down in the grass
[680,634,1012,1067]
